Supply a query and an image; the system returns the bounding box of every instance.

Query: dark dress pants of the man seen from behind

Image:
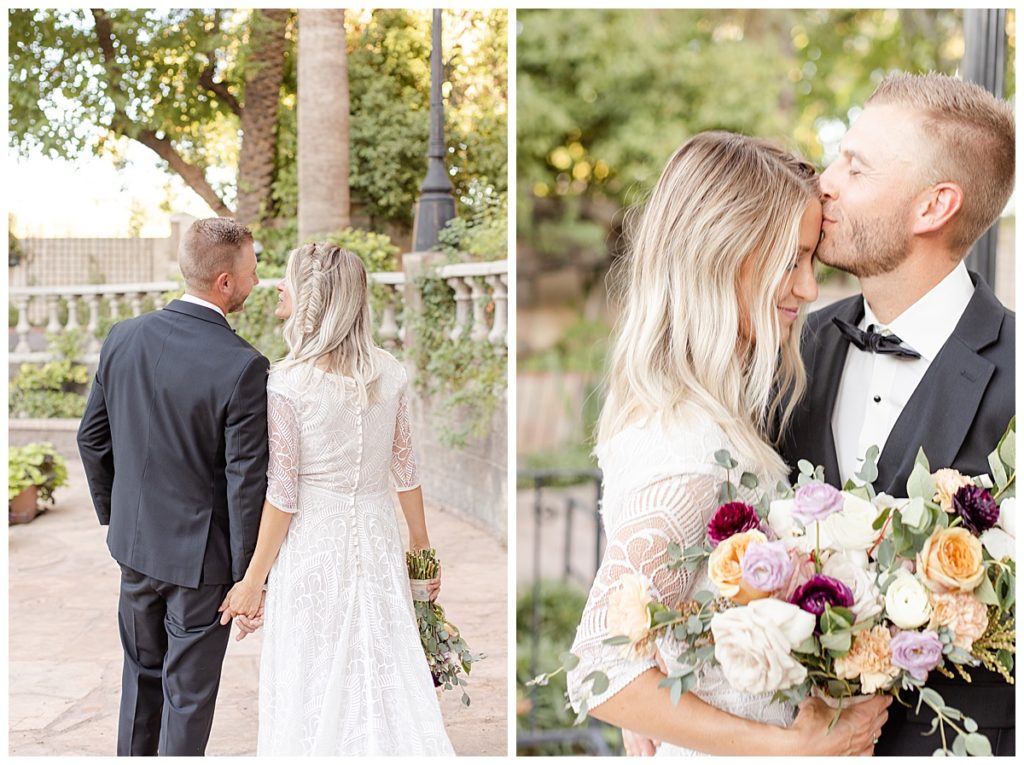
[118,565,230,756]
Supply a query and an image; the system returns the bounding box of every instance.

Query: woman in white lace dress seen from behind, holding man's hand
[225,245,455,756]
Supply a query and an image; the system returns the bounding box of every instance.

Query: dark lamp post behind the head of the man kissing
[962,8,1007,286]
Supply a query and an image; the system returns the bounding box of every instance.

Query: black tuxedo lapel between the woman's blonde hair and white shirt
[801,296,864,486]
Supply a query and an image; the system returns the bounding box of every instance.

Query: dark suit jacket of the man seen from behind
[78,300,269,587]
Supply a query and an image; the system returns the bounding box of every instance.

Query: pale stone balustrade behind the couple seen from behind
[9,260,508,364]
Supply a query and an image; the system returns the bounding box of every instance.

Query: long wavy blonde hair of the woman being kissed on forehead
[598,132,818,476]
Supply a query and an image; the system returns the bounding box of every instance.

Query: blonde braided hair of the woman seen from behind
[276,243,382,406]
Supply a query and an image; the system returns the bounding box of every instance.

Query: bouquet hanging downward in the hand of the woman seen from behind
[406,548,483,707]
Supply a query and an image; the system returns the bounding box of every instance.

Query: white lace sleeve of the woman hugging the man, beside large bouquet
[567,474,717,712]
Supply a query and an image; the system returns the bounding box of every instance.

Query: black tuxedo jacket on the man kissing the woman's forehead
[779,273,1016,755]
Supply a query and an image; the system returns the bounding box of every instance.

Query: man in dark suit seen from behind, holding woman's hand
[78,218,268,755]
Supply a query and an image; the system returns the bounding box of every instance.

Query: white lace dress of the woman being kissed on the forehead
[567,411,795,756]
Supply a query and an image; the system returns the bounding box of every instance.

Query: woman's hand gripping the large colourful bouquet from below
[790,696,893,757]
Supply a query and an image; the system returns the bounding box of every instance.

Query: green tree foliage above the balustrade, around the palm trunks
[8,9,508,229]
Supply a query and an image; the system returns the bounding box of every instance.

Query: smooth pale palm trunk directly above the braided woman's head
[298,9,350,240]
